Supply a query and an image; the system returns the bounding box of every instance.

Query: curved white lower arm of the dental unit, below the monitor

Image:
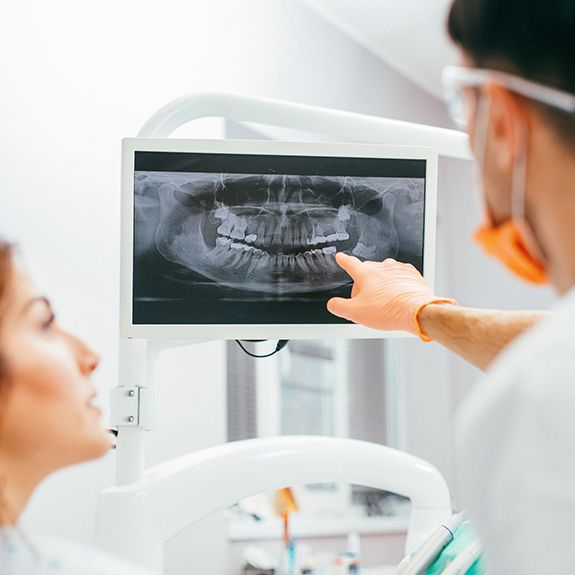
[97,436,451,572]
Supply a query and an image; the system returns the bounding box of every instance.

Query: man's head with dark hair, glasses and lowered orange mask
[448,0,575,292]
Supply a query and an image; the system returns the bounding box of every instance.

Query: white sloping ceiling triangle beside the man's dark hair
[303,0,457,98]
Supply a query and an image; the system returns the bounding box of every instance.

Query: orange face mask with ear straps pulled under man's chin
[475,95,549,284]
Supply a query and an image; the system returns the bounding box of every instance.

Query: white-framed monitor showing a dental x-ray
[121,138,437,340]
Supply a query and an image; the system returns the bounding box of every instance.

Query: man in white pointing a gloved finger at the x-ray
[328,0,575,575]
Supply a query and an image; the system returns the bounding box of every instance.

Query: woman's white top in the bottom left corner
[0,529,157,575]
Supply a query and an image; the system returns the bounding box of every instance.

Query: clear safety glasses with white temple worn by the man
[442,66,575,130]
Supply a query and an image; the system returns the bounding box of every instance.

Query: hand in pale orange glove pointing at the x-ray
[327,253,457,341]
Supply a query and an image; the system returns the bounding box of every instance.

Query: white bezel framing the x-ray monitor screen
[120,138,437,340]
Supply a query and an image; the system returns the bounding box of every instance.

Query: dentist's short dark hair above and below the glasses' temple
[447,0,575,148]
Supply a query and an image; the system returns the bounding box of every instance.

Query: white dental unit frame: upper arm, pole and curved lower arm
[96,94,471,572]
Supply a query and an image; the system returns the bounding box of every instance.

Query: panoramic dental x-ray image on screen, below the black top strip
[133,171,425,324]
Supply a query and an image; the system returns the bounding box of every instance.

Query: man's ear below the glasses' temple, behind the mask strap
[485,84,528,171]
